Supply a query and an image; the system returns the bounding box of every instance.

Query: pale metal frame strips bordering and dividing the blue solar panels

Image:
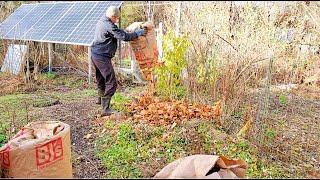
[1,1,123,46]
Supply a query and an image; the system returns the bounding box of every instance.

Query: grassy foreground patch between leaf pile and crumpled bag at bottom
[97,120,288,178]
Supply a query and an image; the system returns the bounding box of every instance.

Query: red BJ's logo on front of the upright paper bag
[36,137,63,169]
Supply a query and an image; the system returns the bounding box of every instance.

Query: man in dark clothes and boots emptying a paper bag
[91,6,145,116]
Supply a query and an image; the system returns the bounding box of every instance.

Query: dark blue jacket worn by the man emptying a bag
[91,16,138,59]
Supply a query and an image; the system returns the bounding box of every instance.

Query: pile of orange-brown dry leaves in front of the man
[128,95,222,125]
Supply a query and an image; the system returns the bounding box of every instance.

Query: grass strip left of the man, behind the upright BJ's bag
[0,85,97,147]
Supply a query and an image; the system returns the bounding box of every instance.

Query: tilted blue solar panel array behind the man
[0,1,122,46]
